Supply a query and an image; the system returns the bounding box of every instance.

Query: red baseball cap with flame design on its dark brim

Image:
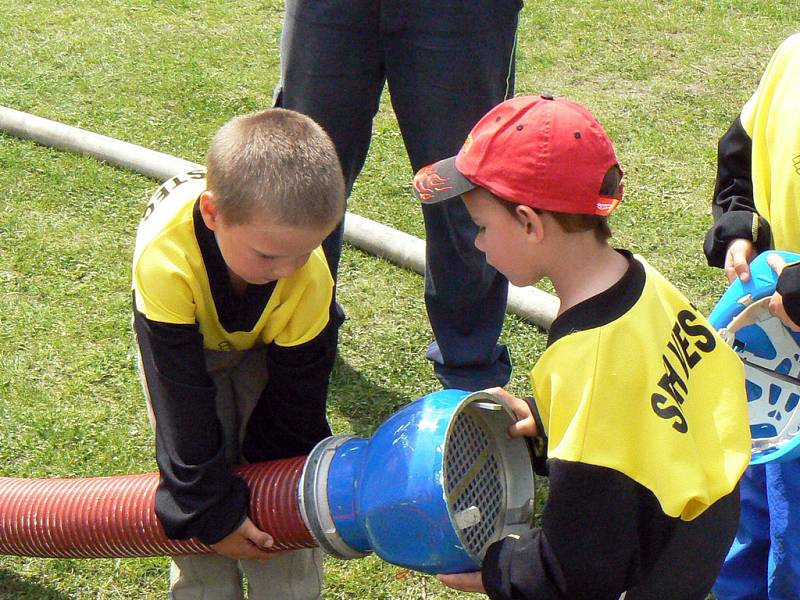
[414,95,622,215]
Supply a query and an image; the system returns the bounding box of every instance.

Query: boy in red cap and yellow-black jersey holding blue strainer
[414,96,750,600]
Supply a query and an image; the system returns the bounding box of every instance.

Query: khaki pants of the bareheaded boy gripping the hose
[139,348,322,600]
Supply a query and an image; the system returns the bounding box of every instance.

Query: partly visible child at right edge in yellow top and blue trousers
[704,34,800,600]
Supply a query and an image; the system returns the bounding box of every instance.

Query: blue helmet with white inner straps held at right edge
[709,251,800,464]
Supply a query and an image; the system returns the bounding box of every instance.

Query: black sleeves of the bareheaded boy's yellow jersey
[134,311,340,544]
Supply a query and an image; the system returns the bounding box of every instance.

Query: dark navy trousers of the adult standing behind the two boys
[276,0,522,390]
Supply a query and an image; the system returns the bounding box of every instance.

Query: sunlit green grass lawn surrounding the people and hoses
[0,0,800,600]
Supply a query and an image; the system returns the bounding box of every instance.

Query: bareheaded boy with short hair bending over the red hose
[132,109,344,600]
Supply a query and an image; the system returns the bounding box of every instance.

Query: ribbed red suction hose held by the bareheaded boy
[0,457,317,558]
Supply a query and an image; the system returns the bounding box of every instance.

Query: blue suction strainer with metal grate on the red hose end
[301,390,534,574]
